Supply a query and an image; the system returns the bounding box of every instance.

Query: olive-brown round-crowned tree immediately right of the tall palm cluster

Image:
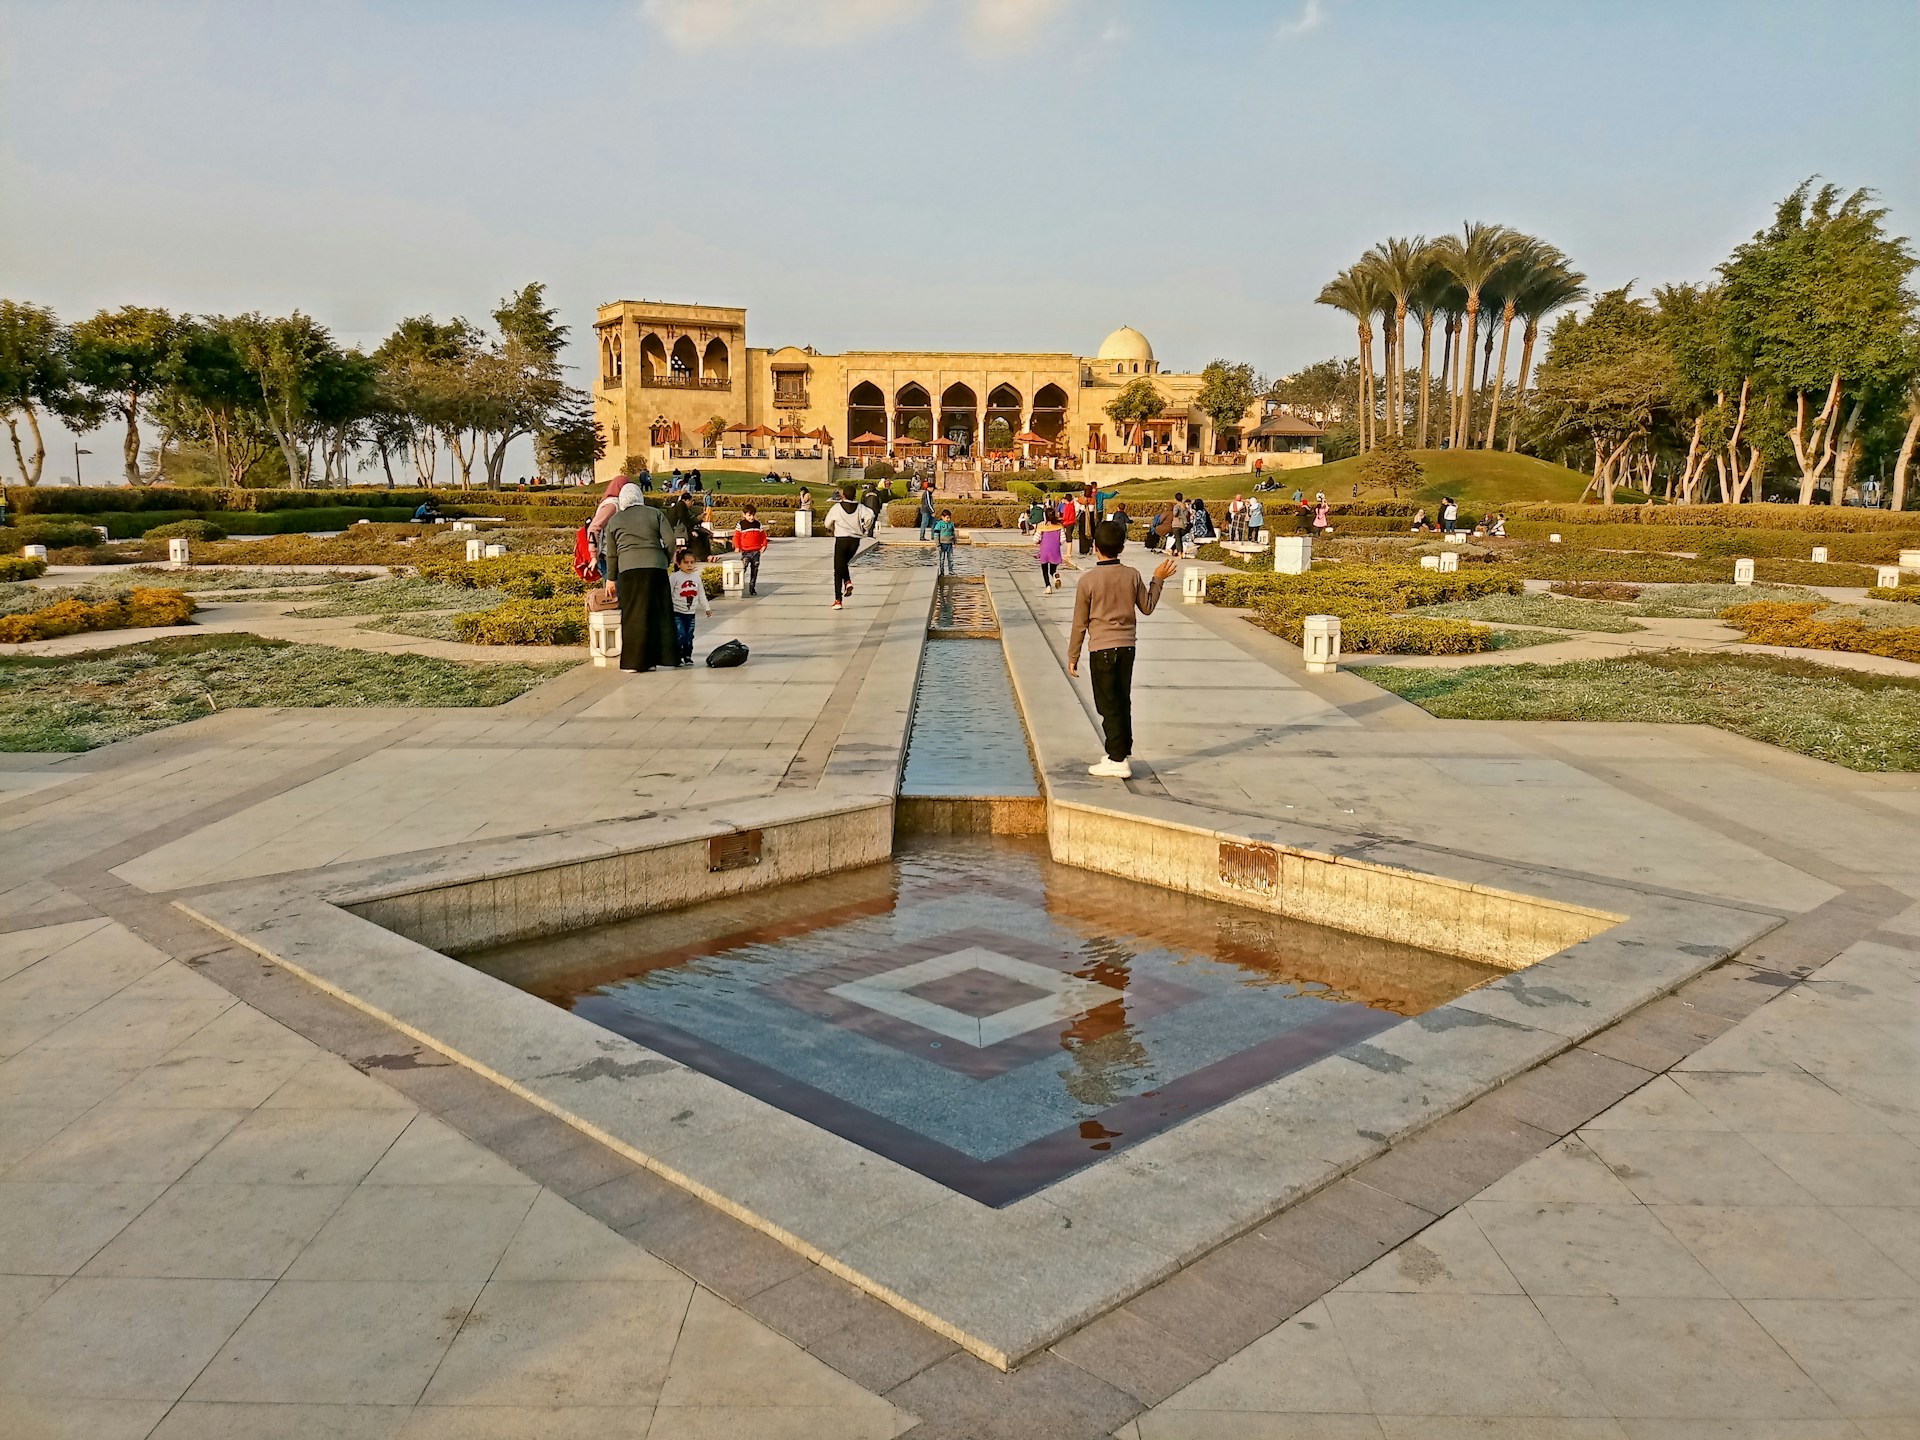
[1534,286,1676,505]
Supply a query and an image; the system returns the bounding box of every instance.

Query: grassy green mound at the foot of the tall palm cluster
[1119,449,1588,515]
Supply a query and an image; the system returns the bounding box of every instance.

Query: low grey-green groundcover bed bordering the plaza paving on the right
[1365,653,1920,770]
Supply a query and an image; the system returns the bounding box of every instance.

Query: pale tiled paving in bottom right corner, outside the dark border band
[1121,937,1920,1440]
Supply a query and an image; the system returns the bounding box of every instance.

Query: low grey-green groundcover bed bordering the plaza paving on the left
[0,641,578,751]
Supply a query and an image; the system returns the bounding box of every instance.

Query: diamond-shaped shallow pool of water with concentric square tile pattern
[461,837,1505,1206]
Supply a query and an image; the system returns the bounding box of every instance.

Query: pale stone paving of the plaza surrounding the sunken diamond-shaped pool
[0,541,1920,1440]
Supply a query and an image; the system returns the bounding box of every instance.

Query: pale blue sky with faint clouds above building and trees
[0,0,1920,482]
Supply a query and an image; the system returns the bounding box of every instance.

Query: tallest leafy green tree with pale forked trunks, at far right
[1720,180,1914,505]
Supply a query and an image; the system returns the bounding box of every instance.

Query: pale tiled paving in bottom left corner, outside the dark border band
[0,920,912,1440]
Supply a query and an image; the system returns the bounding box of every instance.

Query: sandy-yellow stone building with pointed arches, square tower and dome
[593,300,1319,480]
